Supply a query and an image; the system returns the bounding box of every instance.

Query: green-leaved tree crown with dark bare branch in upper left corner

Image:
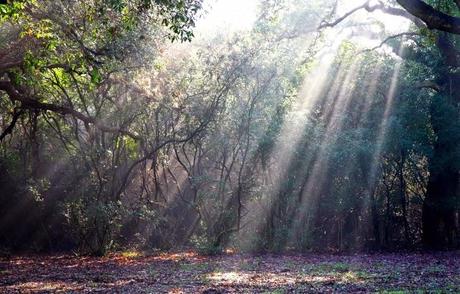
[0,0,201,140]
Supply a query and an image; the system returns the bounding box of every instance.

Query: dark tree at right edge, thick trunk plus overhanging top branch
[321,0,460,248]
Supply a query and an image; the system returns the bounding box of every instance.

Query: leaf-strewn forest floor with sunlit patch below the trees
[0,252,460,293]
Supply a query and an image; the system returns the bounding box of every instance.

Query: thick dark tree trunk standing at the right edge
[422,72,460,249]
